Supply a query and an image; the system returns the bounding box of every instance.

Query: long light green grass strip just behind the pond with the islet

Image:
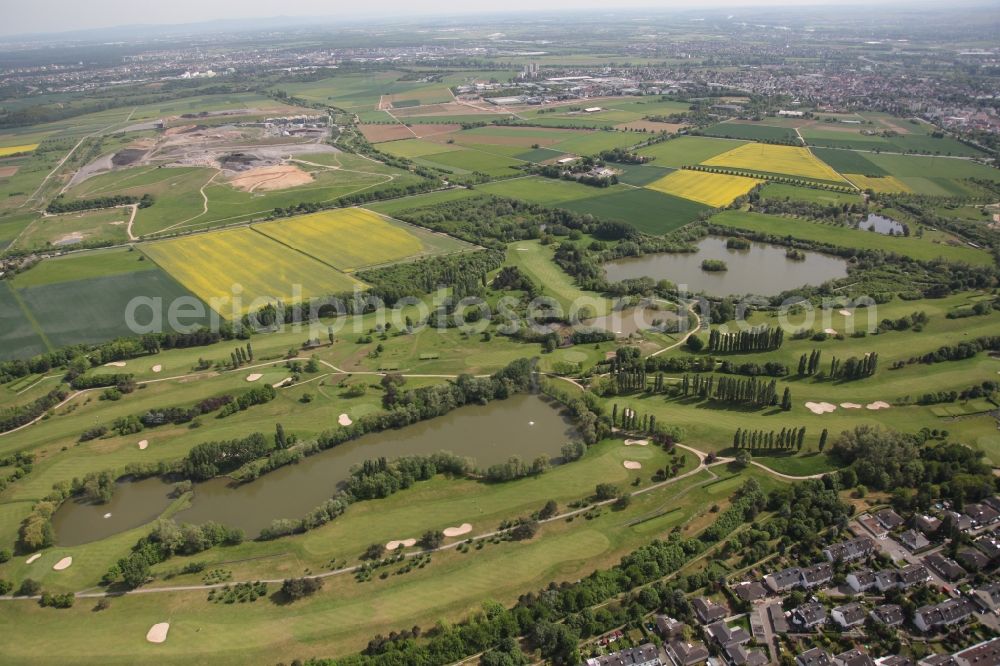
[712,211,993,266]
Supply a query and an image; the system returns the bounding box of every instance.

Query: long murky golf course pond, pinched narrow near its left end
[52,395,575,546]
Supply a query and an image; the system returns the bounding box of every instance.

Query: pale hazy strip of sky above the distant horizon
[0,0,885,35]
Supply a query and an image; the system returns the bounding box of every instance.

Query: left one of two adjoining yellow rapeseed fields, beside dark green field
[141,227,363,318]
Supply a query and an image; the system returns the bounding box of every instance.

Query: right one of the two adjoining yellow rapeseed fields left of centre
[254,208,424,271]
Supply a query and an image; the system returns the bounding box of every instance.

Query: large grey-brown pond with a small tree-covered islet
[604,236,847,296]
